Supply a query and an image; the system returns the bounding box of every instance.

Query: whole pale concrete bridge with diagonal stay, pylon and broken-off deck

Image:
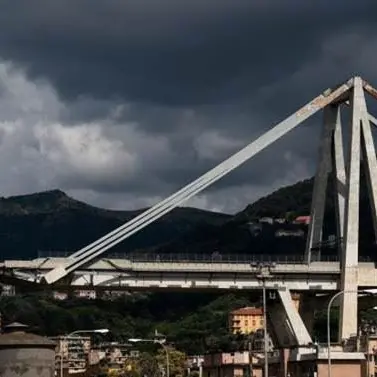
[1,76,377,349]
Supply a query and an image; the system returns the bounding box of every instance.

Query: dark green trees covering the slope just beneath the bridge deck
[0,293,377,355]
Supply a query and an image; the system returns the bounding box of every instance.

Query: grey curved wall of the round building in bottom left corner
[0,348,55,377]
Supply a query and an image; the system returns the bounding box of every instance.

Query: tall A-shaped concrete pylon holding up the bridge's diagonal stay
[305,77,377,340]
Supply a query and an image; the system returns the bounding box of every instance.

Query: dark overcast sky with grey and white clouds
[0,0,377,212]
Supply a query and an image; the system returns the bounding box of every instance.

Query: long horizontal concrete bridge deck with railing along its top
[0,256,377,291]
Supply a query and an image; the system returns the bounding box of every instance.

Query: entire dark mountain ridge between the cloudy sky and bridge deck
[0,172,375,259]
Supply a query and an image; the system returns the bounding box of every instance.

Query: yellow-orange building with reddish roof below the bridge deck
[229,306,264,334]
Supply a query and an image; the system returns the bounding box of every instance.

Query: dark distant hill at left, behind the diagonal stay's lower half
[0,190,231,259]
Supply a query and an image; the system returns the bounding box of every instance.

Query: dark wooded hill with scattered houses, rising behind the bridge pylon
[153,174,375,257]
